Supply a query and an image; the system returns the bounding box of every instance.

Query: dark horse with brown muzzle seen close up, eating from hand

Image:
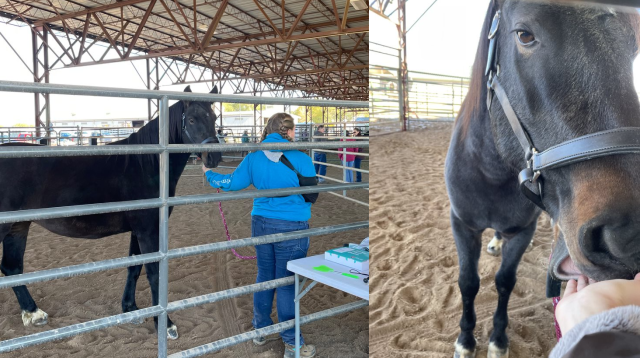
[445,0,640,357]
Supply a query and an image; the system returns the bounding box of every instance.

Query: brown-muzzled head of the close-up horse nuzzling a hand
[479,0,640,281]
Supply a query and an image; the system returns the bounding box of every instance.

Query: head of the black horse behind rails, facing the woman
[181,86,222,168]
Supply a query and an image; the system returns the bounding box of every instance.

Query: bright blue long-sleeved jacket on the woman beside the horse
[206,133,316,221]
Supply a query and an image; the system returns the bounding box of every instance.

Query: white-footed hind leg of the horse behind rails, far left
[0,222,49,327]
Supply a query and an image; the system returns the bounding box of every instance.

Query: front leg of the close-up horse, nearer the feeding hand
[487,221,536,358]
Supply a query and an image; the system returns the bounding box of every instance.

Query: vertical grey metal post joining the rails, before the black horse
[158,96,169,358]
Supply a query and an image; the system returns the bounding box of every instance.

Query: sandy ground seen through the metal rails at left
[0,154,369,358]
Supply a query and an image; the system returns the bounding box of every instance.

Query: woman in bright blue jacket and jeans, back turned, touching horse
[202,113,316,358]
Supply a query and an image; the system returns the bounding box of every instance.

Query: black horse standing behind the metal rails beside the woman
[0,87,221,339]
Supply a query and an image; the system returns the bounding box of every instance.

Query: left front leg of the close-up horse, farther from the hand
[451,213,482,358]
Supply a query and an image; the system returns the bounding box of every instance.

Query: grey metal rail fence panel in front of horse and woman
[0,81,369,358]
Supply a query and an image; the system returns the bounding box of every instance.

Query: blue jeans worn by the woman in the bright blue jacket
[251,215,309,345]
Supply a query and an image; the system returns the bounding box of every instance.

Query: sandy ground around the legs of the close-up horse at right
[369,123,555,358]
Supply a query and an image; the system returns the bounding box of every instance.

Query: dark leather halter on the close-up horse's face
[485,10,640,210]
